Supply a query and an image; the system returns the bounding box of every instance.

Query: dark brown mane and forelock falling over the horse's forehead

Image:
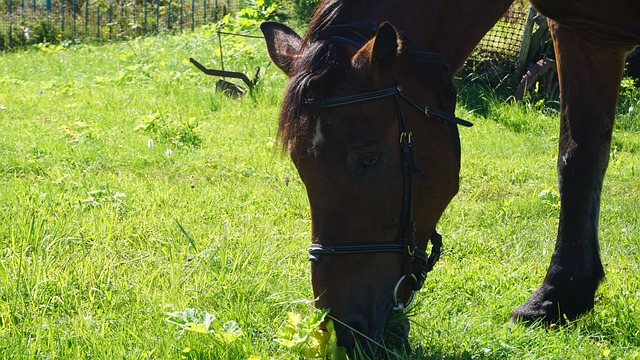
[277,0,361,152]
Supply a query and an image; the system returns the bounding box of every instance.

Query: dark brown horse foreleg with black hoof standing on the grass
[511,21,624,322]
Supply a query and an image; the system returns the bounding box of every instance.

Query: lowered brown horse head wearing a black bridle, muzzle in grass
[262,19,468,348]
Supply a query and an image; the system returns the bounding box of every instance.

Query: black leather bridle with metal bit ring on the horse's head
[305,22,472,310]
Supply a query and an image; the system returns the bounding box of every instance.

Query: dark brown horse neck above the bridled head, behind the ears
[345,0,514,76]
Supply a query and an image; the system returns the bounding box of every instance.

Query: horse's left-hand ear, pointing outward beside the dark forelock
[260,21,302,77]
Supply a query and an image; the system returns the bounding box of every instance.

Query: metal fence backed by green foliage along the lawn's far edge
[0,0,240,50]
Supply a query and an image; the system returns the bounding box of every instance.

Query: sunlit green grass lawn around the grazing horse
[0,32,640,359]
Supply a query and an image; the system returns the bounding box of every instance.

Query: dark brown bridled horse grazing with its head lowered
[261,0,640,349]
